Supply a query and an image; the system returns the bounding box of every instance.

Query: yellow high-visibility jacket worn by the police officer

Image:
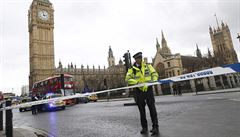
[125,61,158,91]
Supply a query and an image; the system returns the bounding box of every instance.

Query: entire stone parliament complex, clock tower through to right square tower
[28,0,238,91]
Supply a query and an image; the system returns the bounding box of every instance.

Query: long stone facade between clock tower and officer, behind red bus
[55,65,126,92]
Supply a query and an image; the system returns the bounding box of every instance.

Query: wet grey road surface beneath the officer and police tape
[13,92,240,137]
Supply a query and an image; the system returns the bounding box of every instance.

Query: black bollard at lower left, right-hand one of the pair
[5,100,13,137]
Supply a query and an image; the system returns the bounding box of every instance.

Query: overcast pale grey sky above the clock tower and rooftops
[0,0,240,94]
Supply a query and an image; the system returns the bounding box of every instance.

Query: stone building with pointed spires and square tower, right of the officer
[153,22,238,78]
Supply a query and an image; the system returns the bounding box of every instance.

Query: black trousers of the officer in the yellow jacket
[135,87,158,128]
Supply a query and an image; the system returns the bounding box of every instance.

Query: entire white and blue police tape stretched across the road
[0,63,240,111]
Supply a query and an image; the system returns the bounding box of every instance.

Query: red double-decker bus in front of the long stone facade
[32,74,76,105]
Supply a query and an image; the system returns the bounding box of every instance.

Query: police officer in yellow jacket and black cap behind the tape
[125,52,159,135]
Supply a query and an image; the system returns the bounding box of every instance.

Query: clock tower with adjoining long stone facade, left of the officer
[28,0,125,91]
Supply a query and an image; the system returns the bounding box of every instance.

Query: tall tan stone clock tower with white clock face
[28,0,55,89]
